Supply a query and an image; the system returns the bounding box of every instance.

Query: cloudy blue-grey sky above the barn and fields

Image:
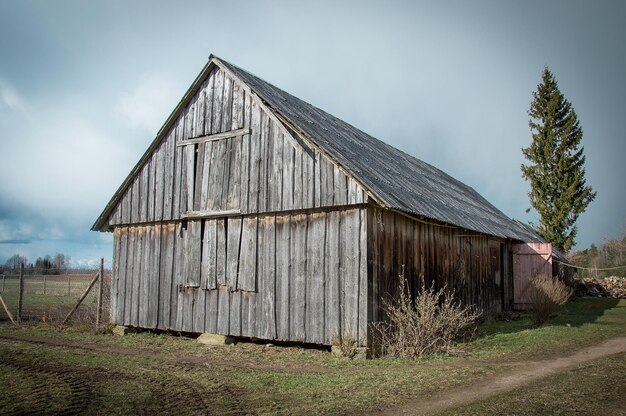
[0,0,626,265]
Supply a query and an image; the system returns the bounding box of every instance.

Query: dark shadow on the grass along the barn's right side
[476,298,626,338]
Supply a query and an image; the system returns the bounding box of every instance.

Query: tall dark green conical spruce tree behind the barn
[522,67,596,253]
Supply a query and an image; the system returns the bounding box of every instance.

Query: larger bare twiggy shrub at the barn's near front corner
[372,279,480,359]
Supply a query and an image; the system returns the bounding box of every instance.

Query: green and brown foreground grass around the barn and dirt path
[0,298,626,415]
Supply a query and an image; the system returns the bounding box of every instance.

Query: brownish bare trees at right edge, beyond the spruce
[570,230,626,278]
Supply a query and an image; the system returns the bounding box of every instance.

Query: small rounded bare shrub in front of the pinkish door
[527,274,573,325]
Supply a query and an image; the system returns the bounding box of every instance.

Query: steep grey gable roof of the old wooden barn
[92,55,540,241]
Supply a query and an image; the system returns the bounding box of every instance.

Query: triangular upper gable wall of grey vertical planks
[108,67,367,226]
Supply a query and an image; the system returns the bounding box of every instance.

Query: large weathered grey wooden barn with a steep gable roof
[93,56,538,346]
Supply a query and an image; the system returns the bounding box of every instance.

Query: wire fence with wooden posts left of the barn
[0,269,111,326]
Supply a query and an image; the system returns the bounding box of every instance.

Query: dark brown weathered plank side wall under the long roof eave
[367,208,512,322]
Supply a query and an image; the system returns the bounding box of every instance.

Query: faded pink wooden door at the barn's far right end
[513,243,552,309]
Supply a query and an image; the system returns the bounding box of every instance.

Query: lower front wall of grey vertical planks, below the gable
[111,208,368,345]
